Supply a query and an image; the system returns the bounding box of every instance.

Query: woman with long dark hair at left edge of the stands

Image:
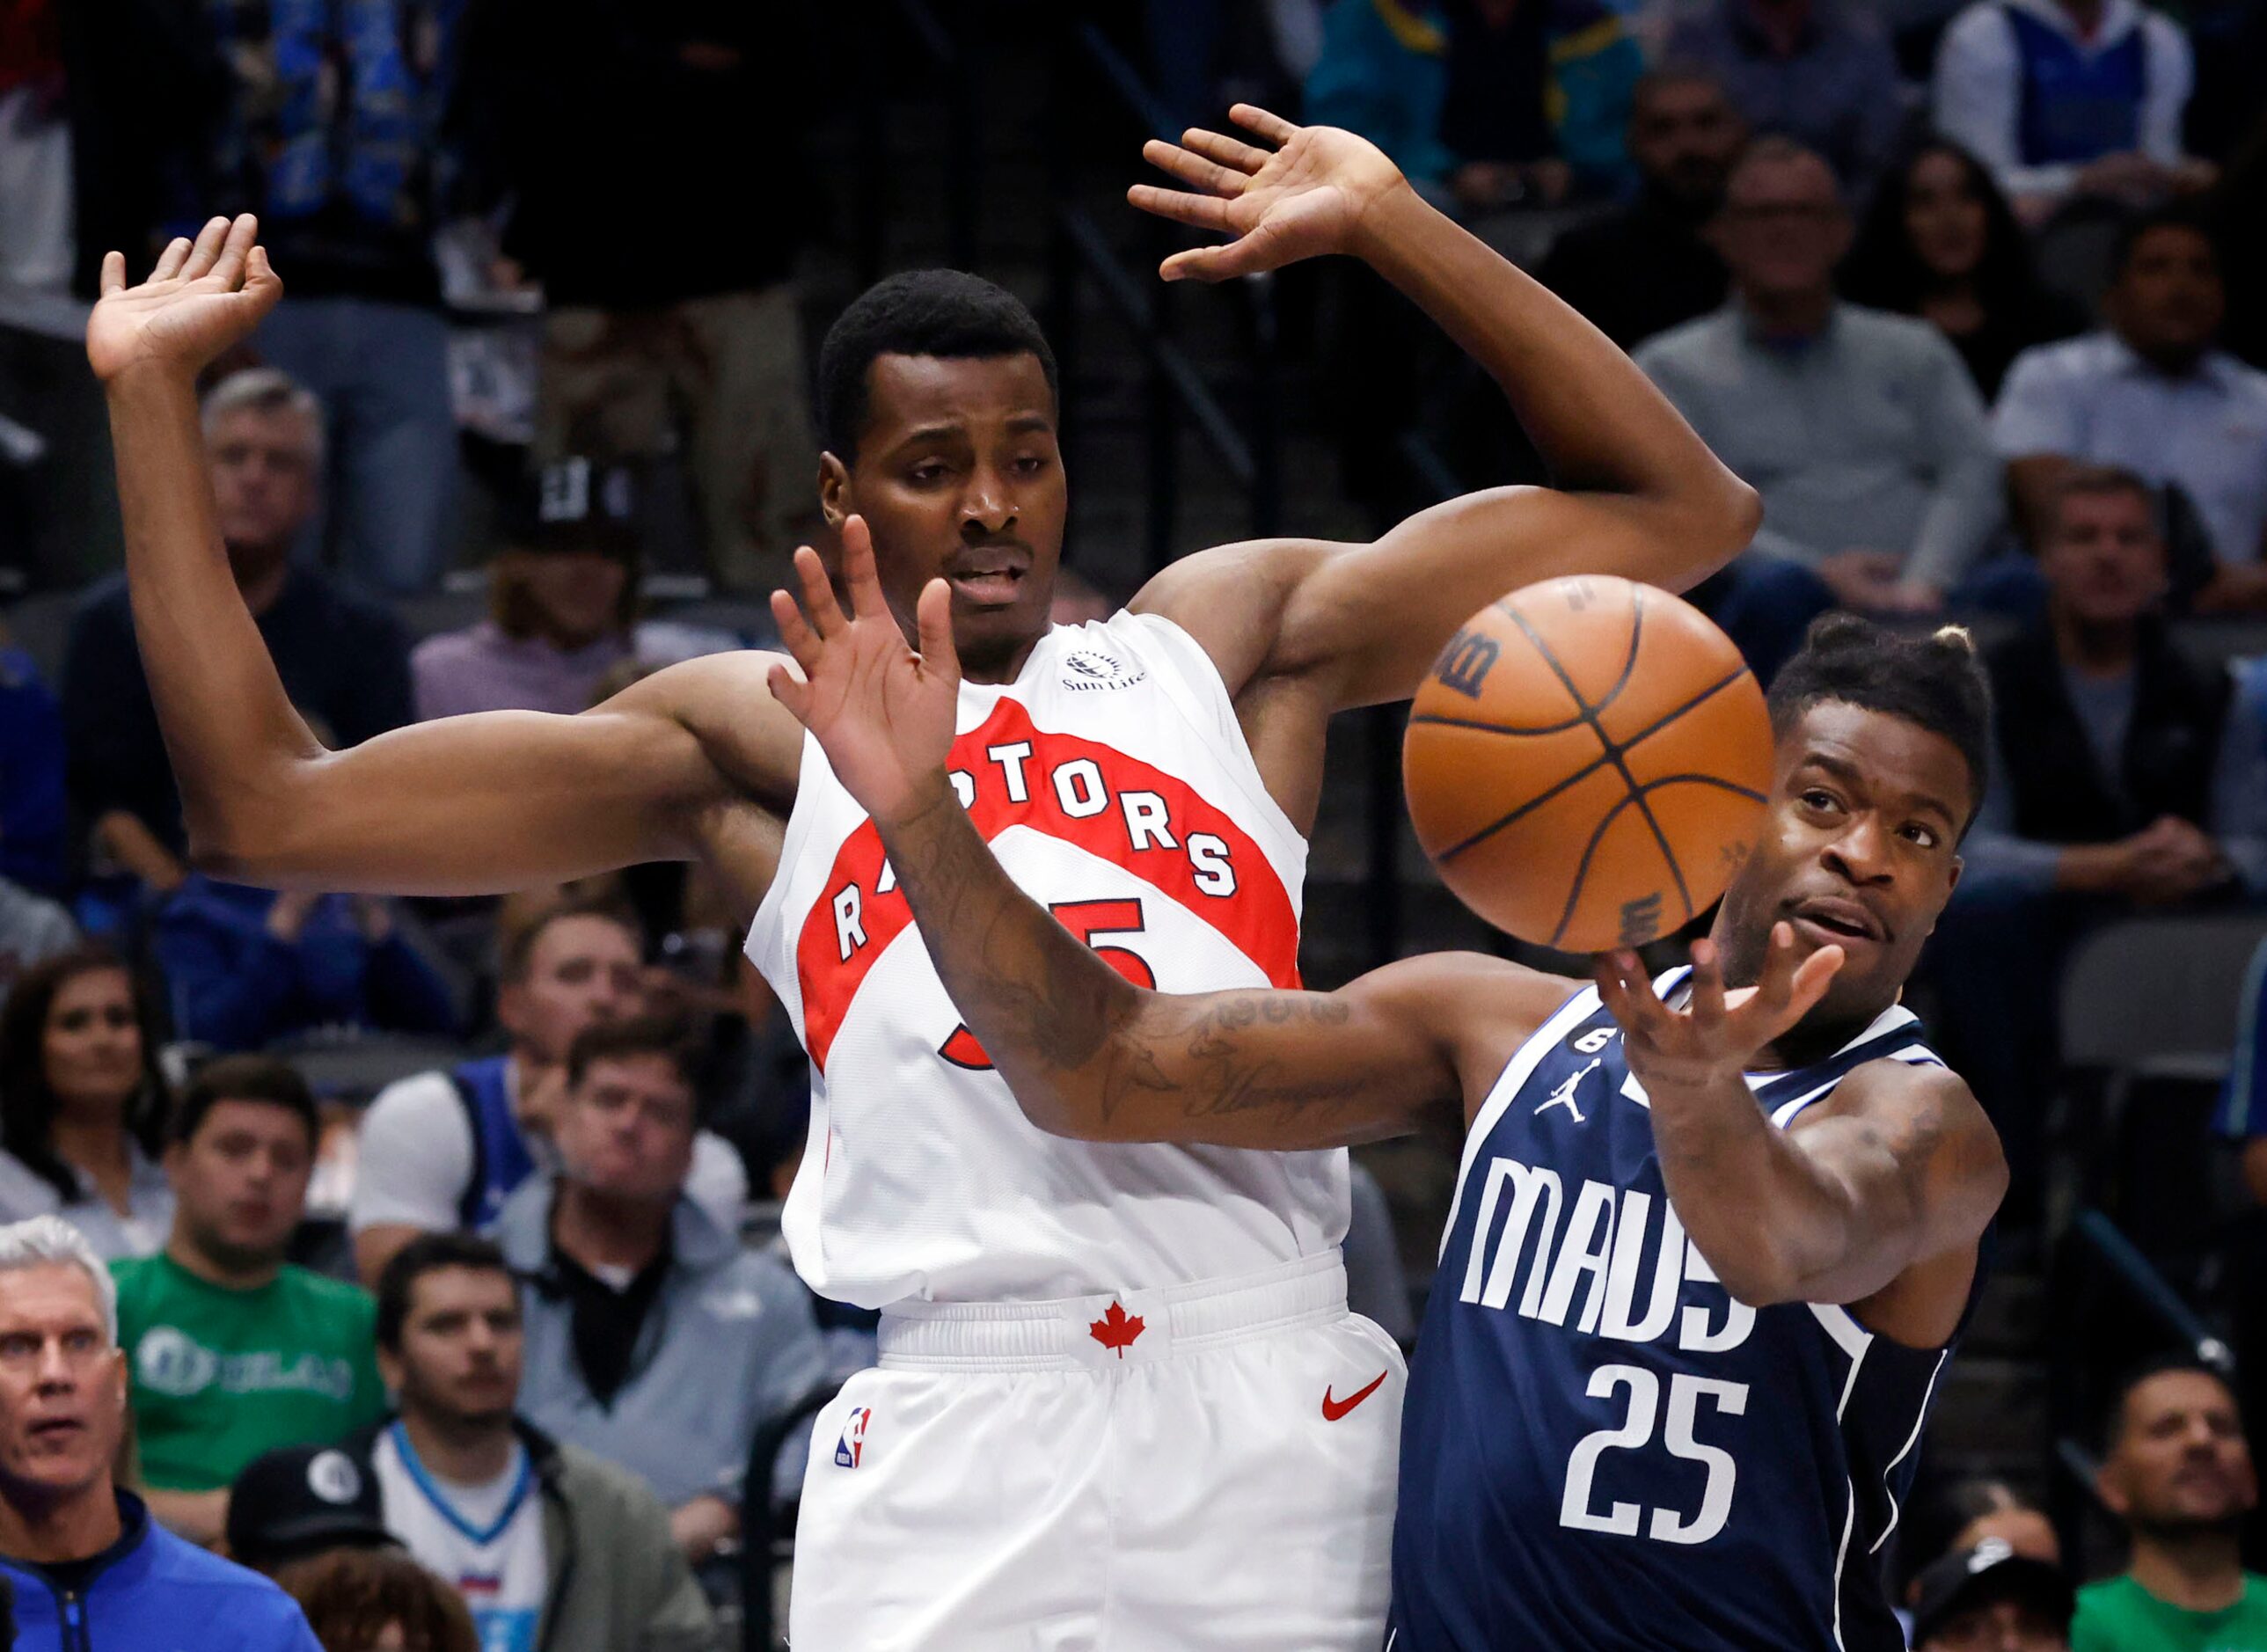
[0,945,172,1258]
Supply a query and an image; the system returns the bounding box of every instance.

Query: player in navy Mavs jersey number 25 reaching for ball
[773,573,2007,1652]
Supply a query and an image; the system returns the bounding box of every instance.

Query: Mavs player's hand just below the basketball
[1596,925,1843,1093]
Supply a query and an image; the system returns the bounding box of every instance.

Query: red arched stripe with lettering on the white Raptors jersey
[796,700,1299,1070]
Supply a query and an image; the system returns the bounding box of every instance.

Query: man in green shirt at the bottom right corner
[2070,1360,2267,1652]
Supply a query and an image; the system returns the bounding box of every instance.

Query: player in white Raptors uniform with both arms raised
[89,109,1757,1652]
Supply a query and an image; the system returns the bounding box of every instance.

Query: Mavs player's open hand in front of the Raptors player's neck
[771,516,962,821]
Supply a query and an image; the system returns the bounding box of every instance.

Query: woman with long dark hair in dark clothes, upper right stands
[1843,138,2086,401]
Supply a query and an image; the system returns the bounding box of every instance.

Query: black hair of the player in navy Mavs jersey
[1771,614,1991,831]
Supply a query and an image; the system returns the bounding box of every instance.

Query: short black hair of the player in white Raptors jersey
[818,270,1064,464]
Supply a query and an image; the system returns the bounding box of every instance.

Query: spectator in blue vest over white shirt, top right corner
[1934,0,2215,224]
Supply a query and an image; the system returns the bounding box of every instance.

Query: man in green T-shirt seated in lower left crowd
[111,1056,385,1543]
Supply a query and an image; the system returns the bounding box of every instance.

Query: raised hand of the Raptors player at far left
[86,213,283,383]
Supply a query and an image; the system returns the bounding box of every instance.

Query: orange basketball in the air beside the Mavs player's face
[1401,574,1771,952]
